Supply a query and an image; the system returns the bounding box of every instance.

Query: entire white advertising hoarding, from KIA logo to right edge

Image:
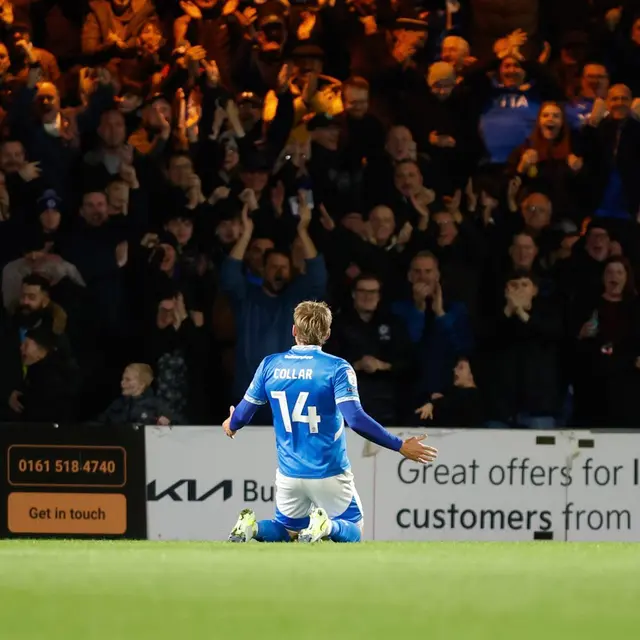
[146,427,640,541]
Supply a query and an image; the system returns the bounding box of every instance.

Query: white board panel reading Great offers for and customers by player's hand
[373,429,569,540]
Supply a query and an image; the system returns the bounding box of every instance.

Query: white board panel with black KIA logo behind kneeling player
[145,427,374,540]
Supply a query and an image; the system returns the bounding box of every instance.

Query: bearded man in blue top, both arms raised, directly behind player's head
[220,197,327,410]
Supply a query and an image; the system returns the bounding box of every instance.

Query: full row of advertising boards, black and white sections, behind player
[0,425,640,541]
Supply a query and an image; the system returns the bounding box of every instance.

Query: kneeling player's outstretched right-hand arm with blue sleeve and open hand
[334,362,438,464]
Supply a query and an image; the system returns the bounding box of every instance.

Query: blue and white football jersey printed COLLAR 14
[244,345,360,478]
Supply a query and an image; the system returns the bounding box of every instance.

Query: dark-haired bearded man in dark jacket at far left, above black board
[0,274,72,420]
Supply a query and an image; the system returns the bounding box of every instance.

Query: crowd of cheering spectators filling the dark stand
[0,0,640,428]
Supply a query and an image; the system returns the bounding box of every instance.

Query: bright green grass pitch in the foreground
[0,541,640,640]
